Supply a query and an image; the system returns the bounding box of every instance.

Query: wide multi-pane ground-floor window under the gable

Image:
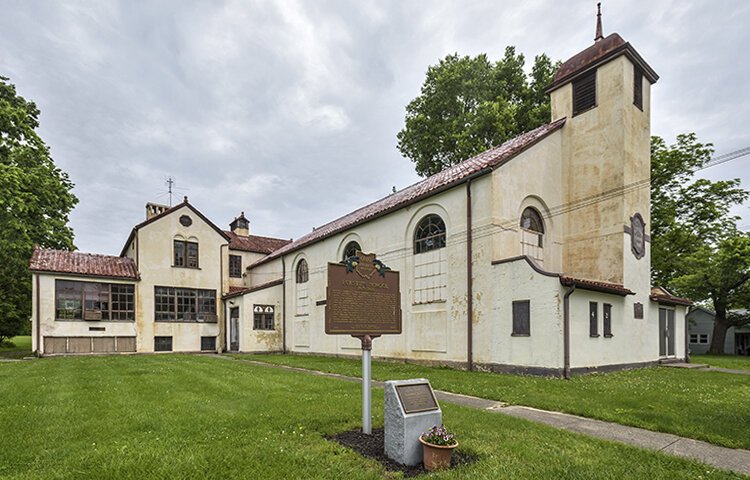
[154,287,217,323]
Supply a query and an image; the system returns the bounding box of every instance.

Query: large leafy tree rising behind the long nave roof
[397,47,559,176]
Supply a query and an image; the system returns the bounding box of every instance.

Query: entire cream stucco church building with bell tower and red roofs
[31,22,689,374]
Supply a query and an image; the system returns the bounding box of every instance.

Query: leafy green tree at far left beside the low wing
[0,77,78,342]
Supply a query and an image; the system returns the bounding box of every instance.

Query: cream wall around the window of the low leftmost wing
[31,274,140,352]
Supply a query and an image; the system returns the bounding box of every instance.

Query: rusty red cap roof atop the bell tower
[547,33,659,93]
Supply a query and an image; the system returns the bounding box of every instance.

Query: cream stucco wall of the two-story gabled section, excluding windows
[136,206,229,352]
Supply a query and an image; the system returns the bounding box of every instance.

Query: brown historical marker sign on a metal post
[325,252,401,336]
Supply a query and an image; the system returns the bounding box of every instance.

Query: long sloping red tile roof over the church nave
[251,118,565,267]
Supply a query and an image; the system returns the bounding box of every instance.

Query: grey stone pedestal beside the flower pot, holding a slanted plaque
[384,378,443,465]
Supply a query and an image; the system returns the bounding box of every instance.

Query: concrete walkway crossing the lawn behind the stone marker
[226,355,750,475]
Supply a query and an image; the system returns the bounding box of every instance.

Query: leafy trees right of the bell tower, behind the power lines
[651,133,750,353]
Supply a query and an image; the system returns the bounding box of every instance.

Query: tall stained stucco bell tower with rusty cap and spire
[547,4,659,290]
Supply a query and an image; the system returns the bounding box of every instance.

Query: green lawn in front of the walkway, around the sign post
[0,355,742,480]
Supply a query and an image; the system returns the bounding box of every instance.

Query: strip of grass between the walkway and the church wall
[239,354,750,449]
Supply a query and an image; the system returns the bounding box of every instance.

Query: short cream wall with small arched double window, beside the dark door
[225,285,283,352]
